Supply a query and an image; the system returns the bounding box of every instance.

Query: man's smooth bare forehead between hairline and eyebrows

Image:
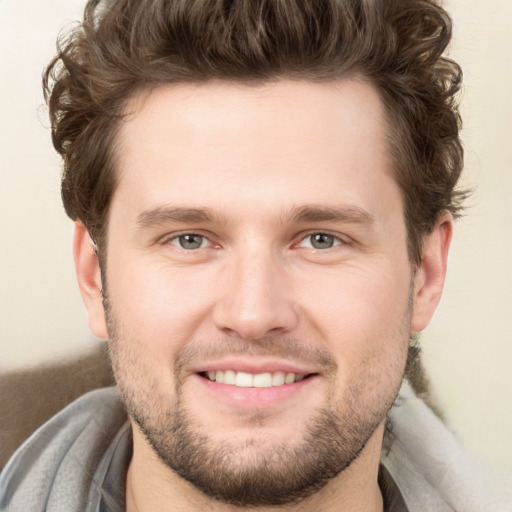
[113,79,400,224]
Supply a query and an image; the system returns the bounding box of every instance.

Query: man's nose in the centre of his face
[213,249,299,340]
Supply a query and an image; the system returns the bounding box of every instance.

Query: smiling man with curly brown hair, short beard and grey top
[0,0,485,512]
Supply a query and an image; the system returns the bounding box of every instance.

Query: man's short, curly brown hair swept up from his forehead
[44,0,464,264]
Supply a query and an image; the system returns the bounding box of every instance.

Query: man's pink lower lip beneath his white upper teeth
[195,375,317,408]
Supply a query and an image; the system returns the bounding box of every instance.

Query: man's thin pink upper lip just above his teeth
[192,358,318,375]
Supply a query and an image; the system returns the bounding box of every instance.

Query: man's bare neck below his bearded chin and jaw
[126,424,384,512]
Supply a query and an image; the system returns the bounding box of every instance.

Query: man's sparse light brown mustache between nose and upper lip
[174,336,337,375]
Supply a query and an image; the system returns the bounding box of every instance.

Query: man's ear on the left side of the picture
[73,221,107,340]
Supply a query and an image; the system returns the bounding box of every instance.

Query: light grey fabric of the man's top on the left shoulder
[0,388,129,512]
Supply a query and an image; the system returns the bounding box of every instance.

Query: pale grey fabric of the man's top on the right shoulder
[381,382,502,512]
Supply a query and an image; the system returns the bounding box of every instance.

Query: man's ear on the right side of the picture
[411,212,453,332]
